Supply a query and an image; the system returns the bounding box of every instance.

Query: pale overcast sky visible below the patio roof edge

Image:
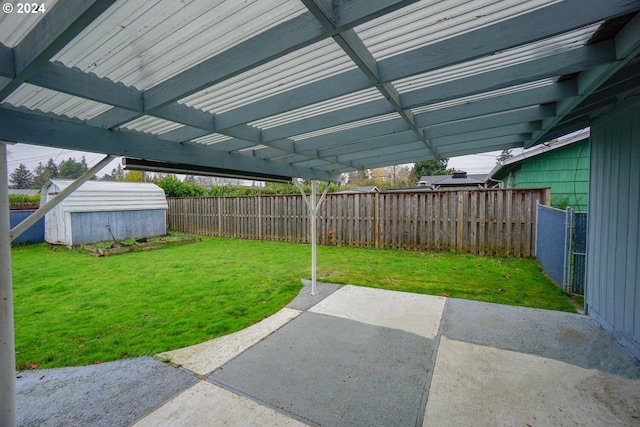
[7,144,504,180]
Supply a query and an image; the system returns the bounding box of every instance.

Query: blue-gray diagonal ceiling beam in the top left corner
[0,0,115,101]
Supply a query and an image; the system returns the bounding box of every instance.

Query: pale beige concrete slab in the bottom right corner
[423,337,640,427]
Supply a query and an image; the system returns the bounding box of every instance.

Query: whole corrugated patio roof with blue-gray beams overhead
[0,0,640,181]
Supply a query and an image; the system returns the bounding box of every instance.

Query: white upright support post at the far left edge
[0,141,16,427]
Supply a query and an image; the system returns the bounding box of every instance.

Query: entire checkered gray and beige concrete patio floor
[17,284,640,427]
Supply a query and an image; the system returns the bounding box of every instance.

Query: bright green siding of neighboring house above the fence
[494,139,589,212]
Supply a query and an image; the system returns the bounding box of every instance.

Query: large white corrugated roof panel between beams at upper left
[52,0,306,90]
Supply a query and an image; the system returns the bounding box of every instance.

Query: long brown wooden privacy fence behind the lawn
[167,189,550,256]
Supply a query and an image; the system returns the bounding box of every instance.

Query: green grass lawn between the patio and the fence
[12,238,574,369]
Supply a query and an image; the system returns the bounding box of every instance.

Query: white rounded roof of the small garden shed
[43,179,167,212]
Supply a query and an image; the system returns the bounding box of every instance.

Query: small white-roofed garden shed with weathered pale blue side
[41,179,167,246]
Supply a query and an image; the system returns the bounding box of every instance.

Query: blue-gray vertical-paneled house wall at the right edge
[585,98,640,358]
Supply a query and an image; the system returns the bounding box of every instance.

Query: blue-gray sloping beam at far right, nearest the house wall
[525,11,640,147]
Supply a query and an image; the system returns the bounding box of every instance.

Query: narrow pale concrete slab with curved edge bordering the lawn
[156,307,302,375]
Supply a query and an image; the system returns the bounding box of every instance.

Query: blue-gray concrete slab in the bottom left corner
[16,357,197,427]
